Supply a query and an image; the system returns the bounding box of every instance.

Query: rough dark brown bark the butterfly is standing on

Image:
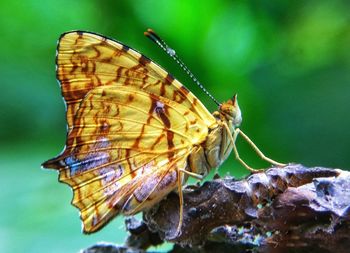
[81,164,350,253]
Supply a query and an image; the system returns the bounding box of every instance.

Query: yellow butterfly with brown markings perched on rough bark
[42,30,283,233]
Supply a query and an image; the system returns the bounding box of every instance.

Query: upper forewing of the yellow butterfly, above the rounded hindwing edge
[56,31,216,130]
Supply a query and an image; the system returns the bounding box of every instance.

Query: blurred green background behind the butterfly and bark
[0,0,350,253]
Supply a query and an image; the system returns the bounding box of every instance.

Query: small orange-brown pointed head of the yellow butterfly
[219,94,242,127]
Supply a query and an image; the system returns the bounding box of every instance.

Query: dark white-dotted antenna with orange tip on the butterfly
[144,29,220,106]
